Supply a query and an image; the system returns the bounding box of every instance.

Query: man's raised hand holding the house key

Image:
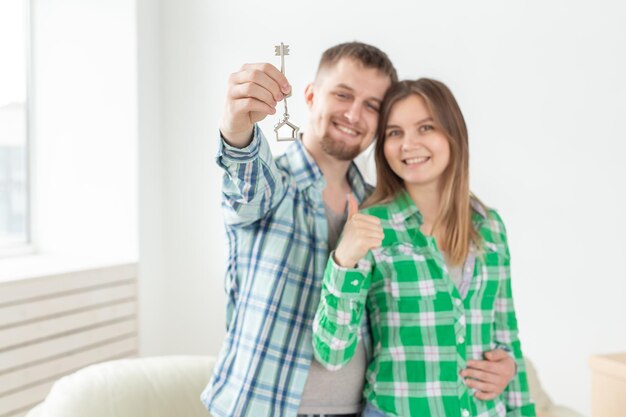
[220,64,291,148]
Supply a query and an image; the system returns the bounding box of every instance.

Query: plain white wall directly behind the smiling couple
[139,0,626,414]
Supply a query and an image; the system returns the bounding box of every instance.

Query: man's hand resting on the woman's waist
[461,349,517,400]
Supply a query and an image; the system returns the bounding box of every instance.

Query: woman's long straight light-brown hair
[364,78,479,265]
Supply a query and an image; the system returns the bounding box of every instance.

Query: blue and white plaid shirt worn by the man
[202,125,371,417]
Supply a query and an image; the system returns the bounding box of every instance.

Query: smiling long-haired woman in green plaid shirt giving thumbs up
[313,78,535,417]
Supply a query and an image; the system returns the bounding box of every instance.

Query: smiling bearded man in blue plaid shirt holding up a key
[202,42,514,417]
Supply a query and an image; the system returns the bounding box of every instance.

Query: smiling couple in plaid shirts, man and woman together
[202,42,535,417]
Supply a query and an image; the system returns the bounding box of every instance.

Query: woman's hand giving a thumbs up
[335,194,385,268]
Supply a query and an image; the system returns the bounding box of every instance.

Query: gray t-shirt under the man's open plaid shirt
[298,204,367,414]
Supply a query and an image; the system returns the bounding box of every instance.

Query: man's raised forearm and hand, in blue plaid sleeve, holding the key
[217,64,290,225]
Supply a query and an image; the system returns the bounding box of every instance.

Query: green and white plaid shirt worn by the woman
[313,192,535,417]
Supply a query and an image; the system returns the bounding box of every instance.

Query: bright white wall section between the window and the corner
[31,0,137,263]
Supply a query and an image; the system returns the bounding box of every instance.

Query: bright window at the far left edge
[0,0,30,255]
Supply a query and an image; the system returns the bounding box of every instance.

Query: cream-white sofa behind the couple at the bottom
[26,356,582,417]
